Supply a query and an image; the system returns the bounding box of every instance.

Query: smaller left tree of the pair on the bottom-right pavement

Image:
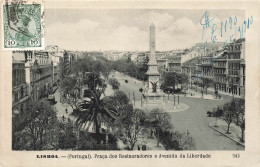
[222,102,235,134]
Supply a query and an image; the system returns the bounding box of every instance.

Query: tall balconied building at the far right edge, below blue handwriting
[213,39,245,97]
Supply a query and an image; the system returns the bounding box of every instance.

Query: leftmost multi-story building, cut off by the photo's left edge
[12,59,29,114]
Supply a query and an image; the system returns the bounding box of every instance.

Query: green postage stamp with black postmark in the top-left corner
[2,1,44,50]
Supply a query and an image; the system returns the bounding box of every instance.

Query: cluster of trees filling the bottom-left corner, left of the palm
[12,99,77,150]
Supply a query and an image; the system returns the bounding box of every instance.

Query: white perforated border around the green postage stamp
[0,0,45,51]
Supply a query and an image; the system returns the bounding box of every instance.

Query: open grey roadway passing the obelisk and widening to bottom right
[114,72,244,150]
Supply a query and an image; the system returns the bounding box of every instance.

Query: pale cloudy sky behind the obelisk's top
[44,9,245,51]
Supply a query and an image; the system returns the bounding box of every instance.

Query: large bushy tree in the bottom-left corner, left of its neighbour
[16,100,58,150]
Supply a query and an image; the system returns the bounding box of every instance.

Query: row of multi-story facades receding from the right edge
[193,39,245,97]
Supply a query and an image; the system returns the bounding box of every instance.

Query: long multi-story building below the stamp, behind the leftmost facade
[13,51,53,100]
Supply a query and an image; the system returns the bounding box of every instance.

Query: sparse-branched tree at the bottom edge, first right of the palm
[114,108,146,150]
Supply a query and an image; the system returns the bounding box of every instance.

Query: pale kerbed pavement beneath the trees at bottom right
[209,119,245,147]
